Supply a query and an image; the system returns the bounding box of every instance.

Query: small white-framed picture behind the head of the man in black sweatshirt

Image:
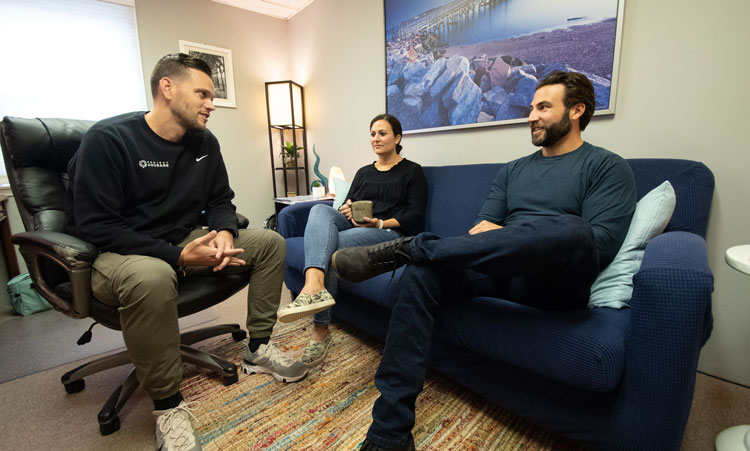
[180,40,237,108]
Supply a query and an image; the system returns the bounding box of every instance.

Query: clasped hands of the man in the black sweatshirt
[178,230,246,272]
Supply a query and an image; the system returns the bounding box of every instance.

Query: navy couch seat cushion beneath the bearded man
[435,297,630,392]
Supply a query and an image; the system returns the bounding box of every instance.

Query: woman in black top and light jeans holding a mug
[278,114,427,367]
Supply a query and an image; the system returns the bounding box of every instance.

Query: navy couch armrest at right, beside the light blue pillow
[613,232,713,450]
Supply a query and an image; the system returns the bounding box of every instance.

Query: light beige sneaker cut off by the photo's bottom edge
[153,401,203,451]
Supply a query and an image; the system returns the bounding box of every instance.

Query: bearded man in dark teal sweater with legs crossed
[332,72,636,451]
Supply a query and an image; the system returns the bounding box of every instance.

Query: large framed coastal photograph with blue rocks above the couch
[384,0,625,133]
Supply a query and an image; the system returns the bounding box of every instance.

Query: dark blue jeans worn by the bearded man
[367,215,599,447]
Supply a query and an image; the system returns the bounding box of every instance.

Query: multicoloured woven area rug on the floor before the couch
[181,320,579,451]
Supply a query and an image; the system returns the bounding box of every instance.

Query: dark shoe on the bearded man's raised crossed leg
[331,237,414,282]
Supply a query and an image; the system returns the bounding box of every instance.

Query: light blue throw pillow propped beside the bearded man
[589,181,676,309]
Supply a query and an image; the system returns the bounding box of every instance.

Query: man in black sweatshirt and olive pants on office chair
[65,54,307,450]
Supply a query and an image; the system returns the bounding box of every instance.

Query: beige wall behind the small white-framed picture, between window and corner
[135,0,290,227]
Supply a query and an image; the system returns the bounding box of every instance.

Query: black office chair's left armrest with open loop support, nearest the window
[12,231,98,318]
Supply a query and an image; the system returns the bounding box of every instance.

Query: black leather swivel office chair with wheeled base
[0,117,250,435]
